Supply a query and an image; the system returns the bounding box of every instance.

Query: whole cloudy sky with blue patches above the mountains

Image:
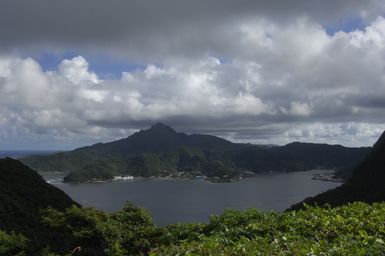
[0,0,385,150]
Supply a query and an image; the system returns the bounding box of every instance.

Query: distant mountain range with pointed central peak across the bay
[22,123,370,182]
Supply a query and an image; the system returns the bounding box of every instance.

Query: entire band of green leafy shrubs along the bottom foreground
[0,203,385,256]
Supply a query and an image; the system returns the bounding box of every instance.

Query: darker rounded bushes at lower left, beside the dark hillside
[43,204,157,255]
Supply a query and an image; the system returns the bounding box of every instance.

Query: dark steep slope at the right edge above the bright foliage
[291,132,385,209]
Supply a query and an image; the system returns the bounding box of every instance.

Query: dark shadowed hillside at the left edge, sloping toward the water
[0,158,78,251]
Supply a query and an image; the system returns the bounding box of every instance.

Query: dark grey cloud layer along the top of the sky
[0,0,384,61]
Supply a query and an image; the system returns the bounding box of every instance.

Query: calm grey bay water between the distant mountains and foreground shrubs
[44,170,339,225]
